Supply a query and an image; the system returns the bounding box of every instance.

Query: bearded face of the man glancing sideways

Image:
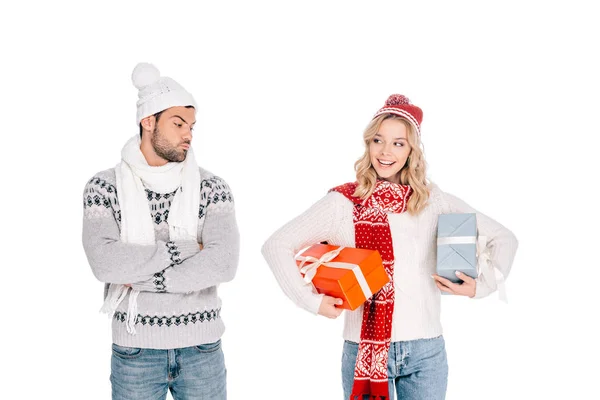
[150,107,196,162]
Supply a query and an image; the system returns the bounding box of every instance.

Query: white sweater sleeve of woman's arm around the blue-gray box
[443,193,518,298]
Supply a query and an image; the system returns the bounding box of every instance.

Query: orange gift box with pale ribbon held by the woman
[296,244,390,310]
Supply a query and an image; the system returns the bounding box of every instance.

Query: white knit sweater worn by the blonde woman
[262,184,518,342]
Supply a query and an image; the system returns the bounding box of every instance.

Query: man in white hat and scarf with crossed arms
[83,63,239,400]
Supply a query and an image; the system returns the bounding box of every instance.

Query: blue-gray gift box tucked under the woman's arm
[437,213,477,283]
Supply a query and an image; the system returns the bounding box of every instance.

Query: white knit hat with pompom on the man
[131,63,196,125]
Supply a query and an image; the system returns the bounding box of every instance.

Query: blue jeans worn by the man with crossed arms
[110,340,227,400]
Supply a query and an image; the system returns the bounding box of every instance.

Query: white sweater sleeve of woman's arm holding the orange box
[262,192,351,314]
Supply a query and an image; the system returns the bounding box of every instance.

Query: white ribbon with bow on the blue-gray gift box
[437,236,508,303]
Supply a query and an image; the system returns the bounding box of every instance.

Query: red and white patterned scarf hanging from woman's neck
[331,180,413,400]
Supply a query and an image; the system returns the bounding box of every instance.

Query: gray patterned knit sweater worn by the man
[83,168,239,349]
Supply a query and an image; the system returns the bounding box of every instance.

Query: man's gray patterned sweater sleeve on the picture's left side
[82,178,199,284]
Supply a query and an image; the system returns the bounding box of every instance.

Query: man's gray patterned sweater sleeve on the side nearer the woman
[132,177,240,293]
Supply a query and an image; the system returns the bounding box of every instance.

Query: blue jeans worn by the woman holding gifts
[342,336,448,400]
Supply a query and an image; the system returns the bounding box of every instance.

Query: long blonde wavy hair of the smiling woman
[354,114,429,214]
